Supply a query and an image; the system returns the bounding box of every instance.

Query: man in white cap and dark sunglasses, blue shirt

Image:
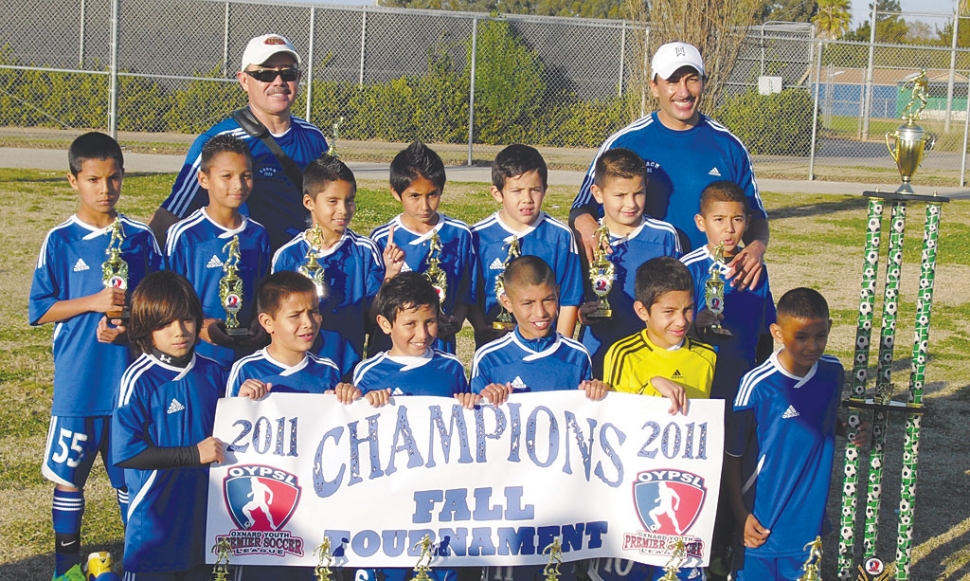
[149,34,328,250]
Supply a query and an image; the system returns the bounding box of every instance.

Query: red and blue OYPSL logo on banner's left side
[222,465,300,531]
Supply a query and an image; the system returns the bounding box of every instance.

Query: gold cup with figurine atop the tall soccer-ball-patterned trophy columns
[886,69,936,194]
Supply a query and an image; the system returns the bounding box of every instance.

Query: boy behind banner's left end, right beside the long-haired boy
[226,271,360,403]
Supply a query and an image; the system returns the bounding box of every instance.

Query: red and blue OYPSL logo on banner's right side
[633,470,707,536]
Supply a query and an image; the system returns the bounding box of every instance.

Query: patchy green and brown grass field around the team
[0,170,970,581]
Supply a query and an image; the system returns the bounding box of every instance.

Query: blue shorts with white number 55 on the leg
[41,416,125,488]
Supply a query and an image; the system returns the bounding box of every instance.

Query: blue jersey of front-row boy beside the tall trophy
[725,352,845,557]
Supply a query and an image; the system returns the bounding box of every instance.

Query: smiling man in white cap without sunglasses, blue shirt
[570,42,768,287]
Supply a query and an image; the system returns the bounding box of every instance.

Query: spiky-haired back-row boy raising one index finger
[370,141,475,353]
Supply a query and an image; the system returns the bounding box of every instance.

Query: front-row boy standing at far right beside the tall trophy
[724,288,859,581]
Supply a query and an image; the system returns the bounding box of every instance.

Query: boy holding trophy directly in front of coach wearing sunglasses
[165,133,270,371]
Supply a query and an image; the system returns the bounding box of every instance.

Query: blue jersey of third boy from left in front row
[354,349,468,397]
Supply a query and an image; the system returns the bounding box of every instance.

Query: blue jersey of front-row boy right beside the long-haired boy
[226,349,340,397]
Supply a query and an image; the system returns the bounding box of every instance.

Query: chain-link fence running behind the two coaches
[0,0,970,184]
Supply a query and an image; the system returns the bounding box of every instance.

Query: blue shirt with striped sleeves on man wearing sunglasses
[162,112,329,249]
